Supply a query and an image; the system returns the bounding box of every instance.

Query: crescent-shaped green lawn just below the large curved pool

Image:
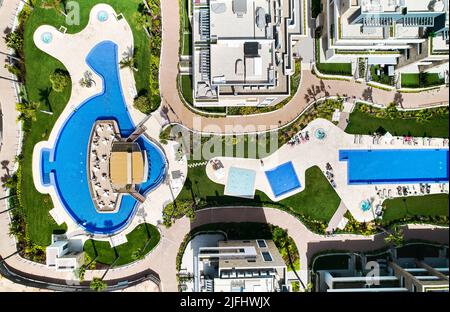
[84,224,160,266]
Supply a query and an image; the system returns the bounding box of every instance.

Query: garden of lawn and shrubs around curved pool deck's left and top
[9,0,159,246]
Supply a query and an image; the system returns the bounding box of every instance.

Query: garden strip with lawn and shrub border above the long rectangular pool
[345,104,449,138]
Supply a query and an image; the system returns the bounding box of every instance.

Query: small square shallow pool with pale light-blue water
[225,167,256,198]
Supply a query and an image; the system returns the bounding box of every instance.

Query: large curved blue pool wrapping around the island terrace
[41,41,166,234]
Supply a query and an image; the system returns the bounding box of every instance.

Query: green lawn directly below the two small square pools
[177,167,340,222]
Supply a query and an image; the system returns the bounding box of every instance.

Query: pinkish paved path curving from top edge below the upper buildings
[160,1,449,134]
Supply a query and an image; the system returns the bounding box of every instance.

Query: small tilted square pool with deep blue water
[265,162,301,197]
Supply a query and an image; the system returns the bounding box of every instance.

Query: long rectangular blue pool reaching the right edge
[339,149,449,184]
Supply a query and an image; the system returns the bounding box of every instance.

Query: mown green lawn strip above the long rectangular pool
[345,110,449,138]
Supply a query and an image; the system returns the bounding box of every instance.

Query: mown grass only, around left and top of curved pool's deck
[21,0,150,246]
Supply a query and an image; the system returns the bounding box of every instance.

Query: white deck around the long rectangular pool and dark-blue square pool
[206,119,448,222]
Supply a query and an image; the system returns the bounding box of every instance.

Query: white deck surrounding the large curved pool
[33,4,188,243]
